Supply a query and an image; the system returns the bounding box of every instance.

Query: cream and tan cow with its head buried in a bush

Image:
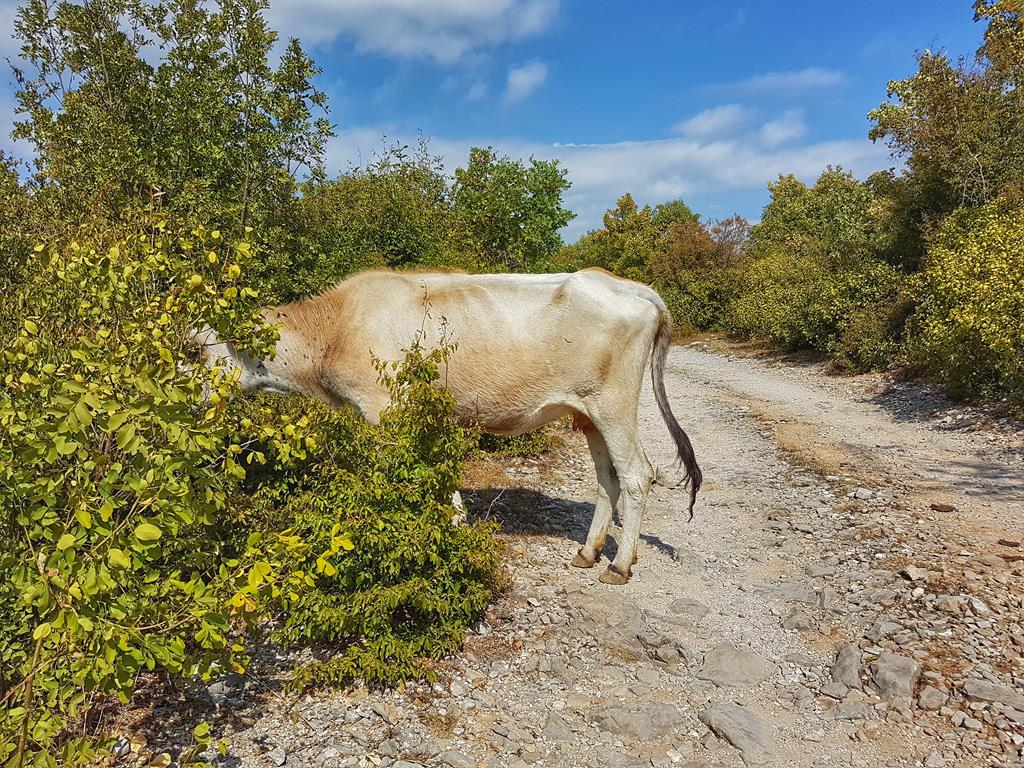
[195,268,701,585]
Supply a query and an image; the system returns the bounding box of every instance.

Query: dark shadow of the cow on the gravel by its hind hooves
[462,488,676,560]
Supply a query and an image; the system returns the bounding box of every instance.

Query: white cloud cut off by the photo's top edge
[260,0,559,62]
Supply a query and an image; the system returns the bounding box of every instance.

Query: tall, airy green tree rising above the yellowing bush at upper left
[15,0,331,230]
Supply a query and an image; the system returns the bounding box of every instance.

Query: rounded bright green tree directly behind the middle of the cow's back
[453,146,573,271]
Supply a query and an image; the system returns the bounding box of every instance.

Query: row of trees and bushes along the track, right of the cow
[557,0,1024,413]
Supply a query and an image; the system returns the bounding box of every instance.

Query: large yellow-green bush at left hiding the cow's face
[0,224,311,765]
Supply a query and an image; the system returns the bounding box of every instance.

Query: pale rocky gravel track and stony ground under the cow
[180,345,1024,768]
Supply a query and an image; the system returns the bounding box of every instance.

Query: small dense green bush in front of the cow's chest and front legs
[244,342,500,687]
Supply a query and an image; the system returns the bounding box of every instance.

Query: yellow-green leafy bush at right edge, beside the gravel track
[913,202,1024,404]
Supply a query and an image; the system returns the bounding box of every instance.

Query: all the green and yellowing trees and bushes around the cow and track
[0,0,1024,766]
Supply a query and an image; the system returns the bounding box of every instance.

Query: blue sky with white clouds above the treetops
[0,0,982,241]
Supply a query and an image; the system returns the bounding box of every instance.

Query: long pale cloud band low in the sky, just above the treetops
[329,128,890,241]
